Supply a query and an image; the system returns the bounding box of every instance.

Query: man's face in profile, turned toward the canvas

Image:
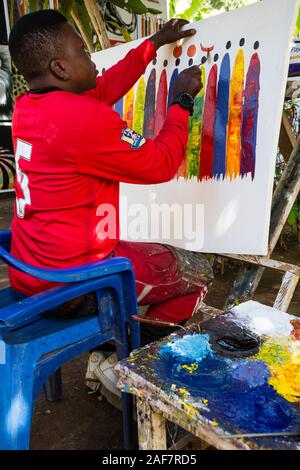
[62,24,98,93]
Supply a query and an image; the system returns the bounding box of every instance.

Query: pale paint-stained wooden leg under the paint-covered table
[137,398,167,450]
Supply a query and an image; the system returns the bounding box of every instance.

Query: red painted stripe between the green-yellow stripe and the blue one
[200,64,218,181]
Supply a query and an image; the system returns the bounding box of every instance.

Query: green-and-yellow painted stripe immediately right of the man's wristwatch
[186,67,205,178]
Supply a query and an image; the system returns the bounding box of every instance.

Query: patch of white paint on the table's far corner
[231,300,299,337]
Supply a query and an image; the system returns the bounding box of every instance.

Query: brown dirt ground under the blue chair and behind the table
[0,194,300,450]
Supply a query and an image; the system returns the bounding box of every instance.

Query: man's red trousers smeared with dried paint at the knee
[114,241,213,323]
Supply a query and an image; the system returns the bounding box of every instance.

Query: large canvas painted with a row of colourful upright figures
[93,0,297,255]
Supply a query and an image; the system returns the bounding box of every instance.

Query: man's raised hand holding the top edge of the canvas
[149,18,196,49]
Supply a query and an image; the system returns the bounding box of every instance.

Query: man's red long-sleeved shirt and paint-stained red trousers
[10,40,211,322]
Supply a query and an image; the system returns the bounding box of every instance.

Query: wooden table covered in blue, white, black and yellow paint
[117,301,300,450]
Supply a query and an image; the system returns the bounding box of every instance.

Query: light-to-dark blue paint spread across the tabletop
[148,330,300,433]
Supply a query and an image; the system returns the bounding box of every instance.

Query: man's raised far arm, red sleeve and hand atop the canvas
[83,19,196,106]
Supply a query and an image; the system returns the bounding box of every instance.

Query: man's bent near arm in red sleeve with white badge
[77,103,189,184]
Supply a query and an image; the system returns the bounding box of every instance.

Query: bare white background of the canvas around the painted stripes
[93,0,298,255]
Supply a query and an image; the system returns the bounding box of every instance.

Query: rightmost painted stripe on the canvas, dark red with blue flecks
[240,53,260,179]
